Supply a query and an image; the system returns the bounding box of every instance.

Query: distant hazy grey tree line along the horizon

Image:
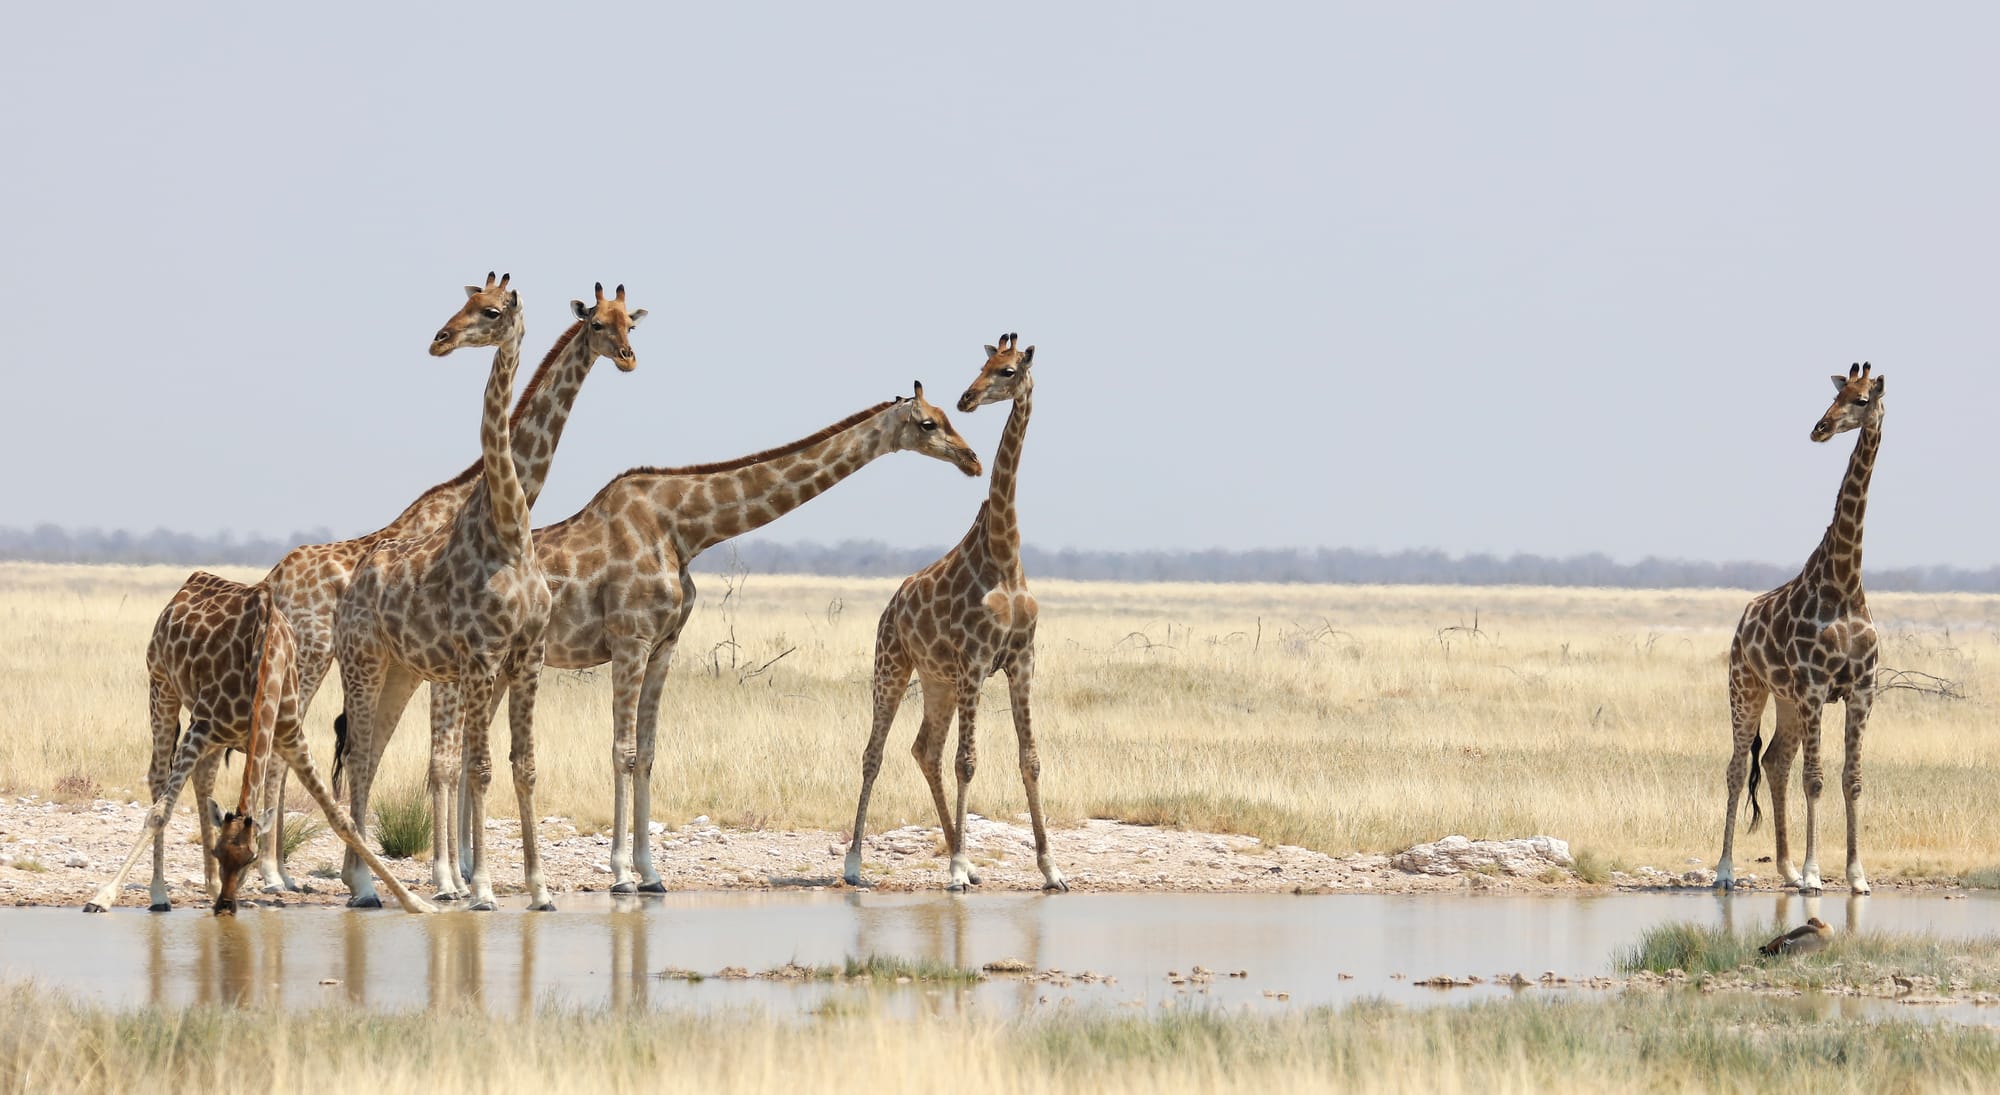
[0,526,2000,593]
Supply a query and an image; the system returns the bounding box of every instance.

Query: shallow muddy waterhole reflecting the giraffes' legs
[0,893,2000,1025]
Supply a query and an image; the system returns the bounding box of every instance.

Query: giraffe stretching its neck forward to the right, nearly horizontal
[496,384,980,893]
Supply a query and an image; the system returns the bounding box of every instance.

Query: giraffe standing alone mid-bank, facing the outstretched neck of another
[842,334,1070,891]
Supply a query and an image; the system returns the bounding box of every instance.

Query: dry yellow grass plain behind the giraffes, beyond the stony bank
[0,563,2000,877]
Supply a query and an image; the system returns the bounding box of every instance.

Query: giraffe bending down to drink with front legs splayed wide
[84,571,436,915]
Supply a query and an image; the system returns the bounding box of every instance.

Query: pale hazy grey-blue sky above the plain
[0,8,2000,565]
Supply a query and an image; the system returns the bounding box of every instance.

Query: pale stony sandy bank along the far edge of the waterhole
[0,795,1942,905]
